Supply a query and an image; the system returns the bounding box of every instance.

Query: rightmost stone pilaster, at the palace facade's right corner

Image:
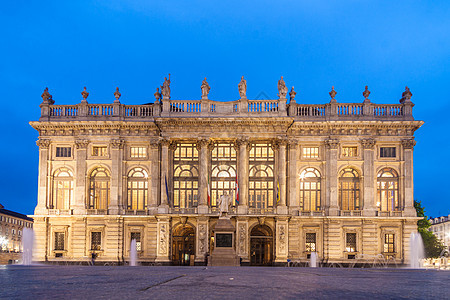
[400,139,417,217]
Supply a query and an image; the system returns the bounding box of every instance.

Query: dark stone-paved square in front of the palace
[0,265,450,299]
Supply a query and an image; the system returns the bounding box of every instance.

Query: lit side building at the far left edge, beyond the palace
[0,204,33,264]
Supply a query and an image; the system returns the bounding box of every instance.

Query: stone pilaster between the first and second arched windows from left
[71,139,89,215]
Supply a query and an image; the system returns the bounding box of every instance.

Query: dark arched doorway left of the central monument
[172,225,195,266]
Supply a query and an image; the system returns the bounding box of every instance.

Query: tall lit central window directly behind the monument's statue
[210,143,237,206]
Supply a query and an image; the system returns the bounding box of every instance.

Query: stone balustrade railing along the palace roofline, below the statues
[40,99,414,121]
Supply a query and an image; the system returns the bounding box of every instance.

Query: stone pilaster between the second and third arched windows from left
[108,139,126,215]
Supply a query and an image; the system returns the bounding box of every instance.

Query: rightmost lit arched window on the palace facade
[377,168,401,211]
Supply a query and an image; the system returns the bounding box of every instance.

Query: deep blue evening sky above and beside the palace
[0,0,450,216]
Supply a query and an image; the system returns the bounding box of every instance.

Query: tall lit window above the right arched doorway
[248,143,275,209]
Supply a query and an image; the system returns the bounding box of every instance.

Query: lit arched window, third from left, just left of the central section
[127,168,148,210]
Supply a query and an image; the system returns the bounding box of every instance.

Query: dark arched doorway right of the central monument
[250,225,273,266]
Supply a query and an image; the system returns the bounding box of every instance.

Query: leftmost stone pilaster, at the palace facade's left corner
[34,139,51,215]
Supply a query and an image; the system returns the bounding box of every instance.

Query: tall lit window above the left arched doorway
[173,143,198,208]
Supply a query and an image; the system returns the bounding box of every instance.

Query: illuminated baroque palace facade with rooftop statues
[30,76,423,265]
